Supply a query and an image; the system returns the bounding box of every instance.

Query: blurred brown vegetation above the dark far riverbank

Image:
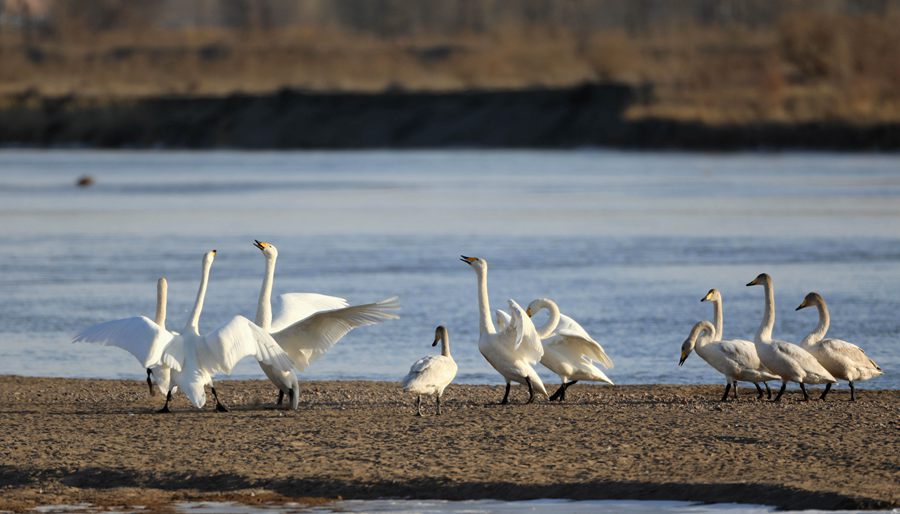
[0,0,900,124]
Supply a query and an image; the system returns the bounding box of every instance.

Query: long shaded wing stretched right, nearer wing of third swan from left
[272,296,400,371]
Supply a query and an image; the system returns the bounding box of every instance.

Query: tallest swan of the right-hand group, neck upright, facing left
[747,273,835,402]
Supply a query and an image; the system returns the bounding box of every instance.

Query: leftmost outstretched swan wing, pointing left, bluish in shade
[72,316,172,368]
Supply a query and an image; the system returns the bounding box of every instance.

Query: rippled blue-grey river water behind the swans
[0,151,900,388]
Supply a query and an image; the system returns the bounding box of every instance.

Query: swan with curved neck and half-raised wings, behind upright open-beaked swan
[516,298,614,402]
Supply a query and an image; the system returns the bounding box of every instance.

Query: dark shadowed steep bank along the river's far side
[0,84,900,151]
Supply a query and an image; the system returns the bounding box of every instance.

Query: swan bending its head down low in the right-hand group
[678,320,778,402]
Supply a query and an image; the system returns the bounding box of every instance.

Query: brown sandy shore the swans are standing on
[0,376,900,511]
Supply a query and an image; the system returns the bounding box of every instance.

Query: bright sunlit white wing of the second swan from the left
[197,316,293,374]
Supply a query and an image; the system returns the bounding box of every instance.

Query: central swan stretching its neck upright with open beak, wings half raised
[460,255,548,405]
